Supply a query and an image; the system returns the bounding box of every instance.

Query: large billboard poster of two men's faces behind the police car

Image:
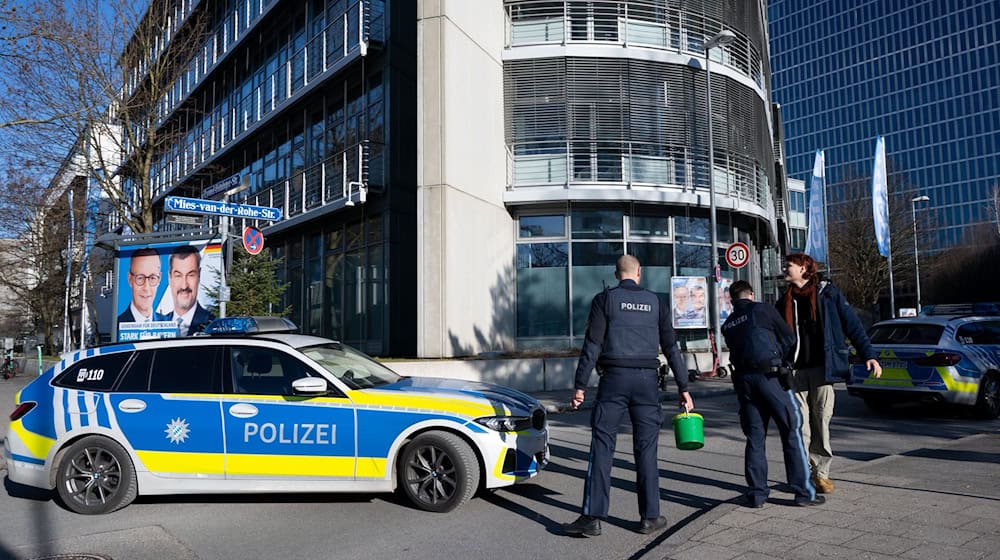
[115,239,222,342]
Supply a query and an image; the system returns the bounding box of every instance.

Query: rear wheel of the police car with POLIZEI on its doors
[56,436,137,515]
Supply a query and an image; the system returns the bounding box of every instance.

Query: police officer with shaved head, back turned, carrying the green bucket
[562,255,694,536]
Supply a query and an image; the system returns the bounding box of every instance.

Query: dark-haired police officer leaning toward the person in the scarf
[722,280,826,508]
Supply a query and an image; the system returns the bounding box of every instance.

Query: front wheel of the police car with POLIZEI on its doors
[397,432,479,513]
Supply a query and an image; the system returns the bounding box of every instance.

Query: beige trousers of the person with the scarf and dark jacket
[794,367,834,478]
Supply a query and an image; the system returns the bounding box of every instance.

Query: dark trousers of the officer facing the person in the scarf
[733,372,816,504]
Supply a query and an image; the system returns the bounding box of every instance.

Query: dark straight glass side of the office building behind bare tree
[125,0,416,354]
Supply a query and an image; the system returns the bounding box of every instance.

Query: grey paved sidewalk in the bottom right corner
[648,430,1000,560]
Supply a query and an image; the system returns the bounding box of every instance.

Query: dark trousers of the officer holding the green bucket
[583,368,663,519]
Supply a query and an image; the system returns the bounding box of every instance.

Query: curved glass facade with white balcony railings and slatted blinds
[503,0,781,346]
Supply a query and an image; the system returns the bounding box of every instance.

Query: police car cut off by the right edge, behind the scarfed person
[847,305,1000,419]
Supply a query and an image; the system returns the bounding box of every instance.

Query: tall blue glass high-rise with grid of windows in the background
[768,0,1000,252]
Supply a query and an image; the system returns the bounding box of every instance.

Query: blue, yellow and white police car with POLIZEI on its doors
[4,317,549,514]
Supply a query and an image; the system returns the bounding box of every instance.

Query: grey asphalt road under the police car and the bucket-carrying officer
[0,372,997,560]
